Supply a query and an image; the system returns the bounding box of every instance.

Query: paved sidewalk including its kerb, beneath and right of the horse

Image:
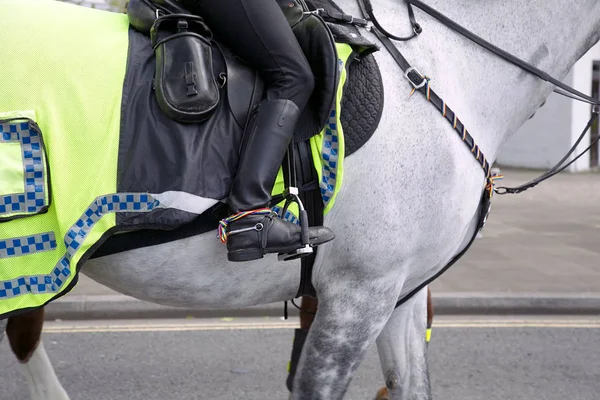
[48,170,600,318]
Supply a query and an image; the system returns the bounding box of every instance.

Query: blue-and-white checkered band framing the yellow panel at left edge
[0,120,48,219]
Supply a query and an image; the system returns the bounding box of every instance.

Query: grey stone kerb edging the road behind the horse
[45,292,600,320]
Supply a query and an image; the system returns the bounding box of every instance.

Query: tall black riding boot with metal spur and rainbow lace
[221,100,334,261]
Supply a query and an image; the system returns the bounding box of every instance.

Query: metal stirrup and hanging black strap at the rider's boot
[277,144,313,261]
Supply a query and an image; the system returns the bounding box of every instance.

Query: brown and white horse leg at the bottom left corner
[6,308,69,400]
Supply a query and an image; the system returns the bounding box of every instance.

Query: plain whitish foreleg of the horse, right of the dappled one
[377,289,433,400]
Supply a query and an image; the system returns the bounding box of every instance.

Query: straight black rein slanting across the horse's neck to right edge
[406,0,600,105]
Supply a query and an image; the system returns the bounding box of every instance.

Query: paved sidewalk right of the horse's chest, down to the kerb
[432,170,600,293]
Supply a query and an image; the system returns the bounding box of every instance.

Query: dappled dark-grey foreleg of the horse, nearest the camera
[293,279,397,400]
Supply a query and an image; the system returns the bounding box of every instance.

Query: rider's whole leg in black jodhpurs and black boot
[181,0,334,261]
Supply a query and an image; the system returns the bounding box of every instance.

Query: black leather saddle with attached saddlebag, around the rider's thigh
[127,0,340,141]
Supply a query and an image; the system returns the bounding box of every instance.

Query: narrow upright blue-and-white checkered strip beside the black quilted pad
[319,107,339,207]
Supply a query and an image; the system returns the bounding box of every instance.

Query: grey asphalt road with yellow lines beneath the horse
[0,317,600,400]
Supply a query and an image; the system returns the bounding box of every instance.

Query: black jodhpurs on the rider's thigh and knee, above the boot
[180,0,314,110]
